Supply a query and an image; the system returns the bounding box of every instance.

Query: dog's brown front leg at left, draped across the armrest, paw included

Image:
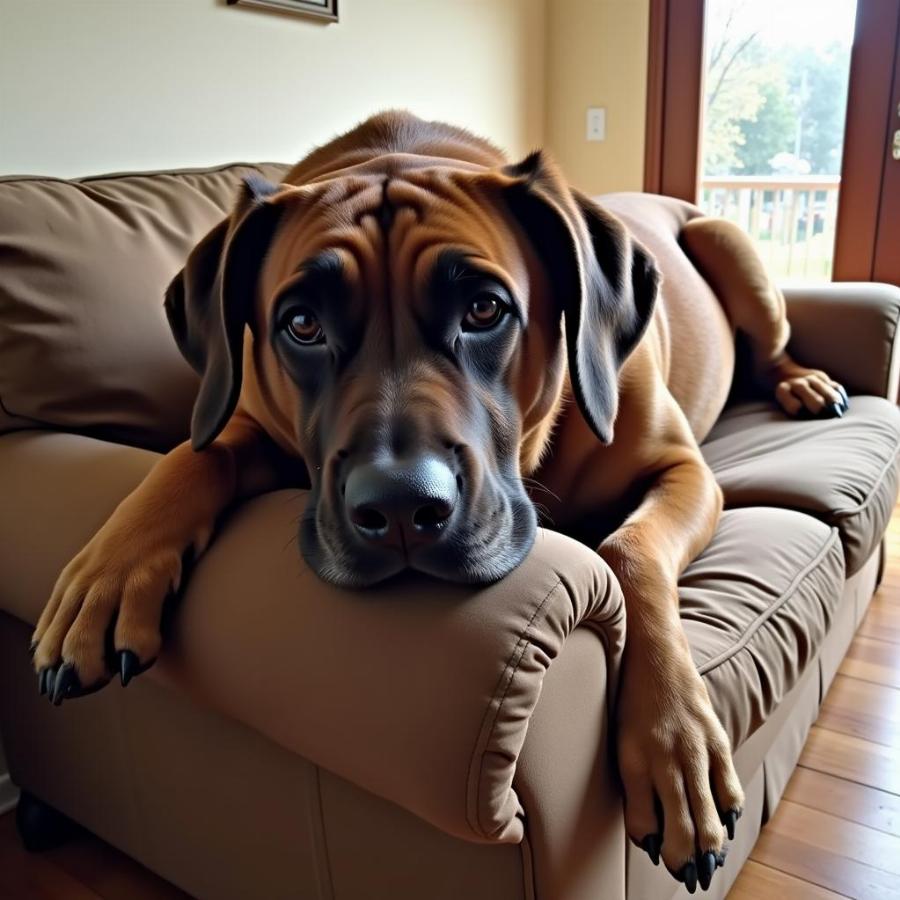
[32,414,288,703]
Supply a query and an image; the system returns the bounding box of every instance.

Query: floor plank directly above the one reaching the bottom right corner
[784,766,900,837]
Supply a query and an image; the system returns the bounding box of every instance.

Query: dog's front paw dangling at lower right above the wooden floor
[618,659,744,894]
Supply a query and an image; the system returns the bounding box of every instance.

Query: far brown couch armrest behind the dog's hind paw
[784,282,900,400]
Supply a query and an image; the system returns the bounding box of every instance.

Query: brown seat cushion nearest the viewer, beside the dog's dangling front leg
[679,507,844,747]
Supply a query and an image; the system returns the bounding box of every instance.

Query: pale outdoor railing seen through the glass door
[699,175,841,281]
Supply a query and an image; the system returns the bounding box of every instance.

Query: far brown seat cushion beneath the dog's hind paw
[703,397,900,575]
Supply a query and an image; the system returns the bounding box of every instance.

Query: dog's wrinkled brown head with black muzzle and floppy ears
[166,154,657,586]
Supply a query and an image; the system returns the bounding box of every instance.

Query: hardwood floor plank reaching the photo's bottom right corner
[751,800,900,900]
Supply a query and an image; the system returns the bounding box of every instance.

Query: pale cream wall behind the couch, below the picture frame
[0,0,553,176]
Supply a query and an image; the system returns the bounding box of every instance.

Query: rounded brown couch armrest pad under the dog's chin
[160,492,624,842]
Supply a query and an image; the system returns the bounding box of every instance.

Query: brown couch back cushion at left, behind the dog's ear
[0,164,286,450]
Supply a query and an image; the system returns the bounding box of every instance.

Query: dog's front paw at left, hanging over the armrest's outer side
[31,520,182,705]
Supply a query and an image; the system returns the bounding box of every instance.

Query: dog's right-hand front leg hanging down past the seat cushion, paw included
[599,440,744,893]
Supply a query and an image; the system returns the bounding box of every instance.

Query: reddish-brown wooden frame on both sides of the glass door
[644,0,900,281]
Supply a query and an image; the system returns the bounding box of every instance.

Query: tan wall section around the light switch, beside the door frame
[544,0,650,194]
